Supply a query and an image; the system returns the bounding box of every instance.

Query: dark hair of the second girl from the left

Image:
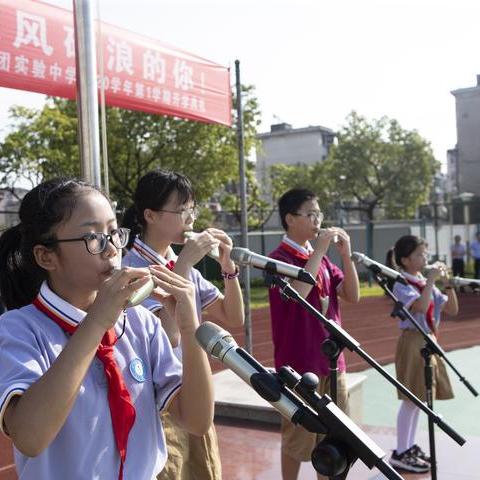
[122,168,195,248]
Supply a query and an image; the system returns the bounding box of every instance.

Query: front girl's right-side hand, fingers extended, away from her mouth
[149,265,198,332]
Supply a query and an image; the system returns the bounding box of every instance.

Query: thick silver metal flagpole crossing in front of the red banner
[73,0,102,187]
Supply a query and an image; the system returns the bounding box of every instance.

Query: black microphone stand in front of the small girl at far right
[367,265,478,480]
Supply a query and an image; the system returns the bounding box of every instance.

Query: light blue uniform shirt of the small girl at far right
[393,271,448,333]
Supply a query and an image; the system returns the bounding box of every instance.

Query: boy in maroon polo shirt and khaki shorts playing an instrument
[269,189,360,480]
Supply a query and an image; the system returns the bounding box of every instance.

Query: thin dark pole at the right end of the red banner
[235,60,253,353]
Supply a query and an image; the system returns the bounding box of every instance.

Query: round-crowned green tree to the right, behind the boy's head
[324,112,440,220]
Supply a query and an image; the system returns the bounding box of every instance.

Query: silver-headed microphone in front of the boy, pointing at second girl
[230,247,317,285]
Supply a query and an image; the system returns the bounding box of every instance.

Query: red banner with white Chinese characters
[0,0,231,125]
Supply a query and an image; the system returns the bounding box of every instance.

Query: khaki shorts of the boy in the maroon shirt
[281,373,348,462]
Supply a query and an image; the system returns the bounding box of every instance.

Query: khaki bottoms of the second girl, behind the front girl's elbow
[157,411,222,480]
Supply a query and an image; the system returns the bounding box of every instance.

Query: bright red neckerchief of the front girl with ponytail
[33,295,136,480]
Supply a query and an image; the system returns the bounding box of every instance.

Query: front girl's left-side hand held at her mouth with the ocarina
[85,267,150,331]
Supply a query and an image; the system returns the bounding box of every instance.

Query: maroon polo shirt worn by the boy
[269,244,345,377]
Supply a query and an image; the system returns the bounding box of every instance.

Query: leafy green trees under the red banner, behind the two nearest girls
[0,86,260,214]
